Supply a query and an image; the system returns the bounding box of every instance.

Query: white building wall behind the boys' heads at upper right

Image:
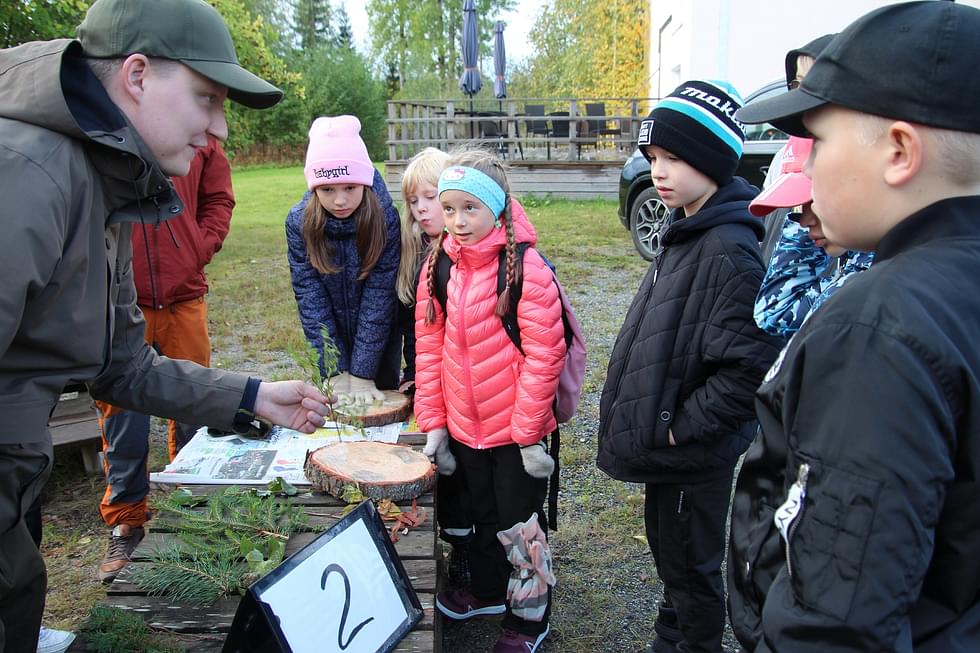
[650,0,980,97]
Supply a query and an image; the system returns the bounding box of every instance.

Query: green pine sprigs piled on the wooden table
[133,486,310,605]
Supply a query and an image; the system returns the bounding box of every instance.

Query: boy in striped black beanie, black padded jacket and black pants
[597,81,778,653]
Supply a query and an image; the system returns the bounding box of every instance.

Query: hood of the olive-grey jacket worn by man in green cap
[0,39,182,216]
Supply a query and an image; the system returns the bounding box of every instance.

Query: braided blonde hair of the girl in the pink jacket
[425,148,523,324]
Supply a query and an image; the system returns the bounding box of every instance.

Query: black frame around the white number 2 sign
[221,500,422,653]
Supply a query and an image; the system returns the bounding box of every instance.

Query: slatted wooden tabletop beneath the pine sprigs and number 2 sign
[82,435,442,653]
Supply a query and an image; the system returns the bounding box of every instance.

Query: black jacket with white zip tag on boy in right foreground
[728,197,980,653]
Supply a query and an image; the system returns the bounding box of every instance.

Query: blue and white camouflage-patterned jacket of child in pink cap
[753,218,874,338]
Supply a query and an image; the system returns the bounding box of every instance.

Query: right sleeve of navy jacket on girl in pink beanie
[350,170,402,379]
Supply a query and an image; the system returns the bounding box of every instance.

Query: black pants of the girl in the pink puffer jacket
[449,439,551,636]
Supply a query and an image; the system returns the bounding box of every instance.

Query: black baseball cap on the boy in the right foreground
[735,0,980,136]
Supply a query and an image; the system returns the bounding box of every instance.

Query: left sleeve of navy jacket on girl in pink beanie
[286,193,349,372]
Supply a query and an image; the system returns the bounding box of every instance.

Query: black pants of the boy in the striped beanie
[643,470,734,653]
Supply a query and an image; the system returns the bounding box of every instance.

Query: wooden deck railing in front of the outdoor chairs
[387,98,656,161]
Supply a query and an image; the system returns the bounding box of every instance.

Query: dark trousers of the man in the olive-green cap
[0,441,52,653]
